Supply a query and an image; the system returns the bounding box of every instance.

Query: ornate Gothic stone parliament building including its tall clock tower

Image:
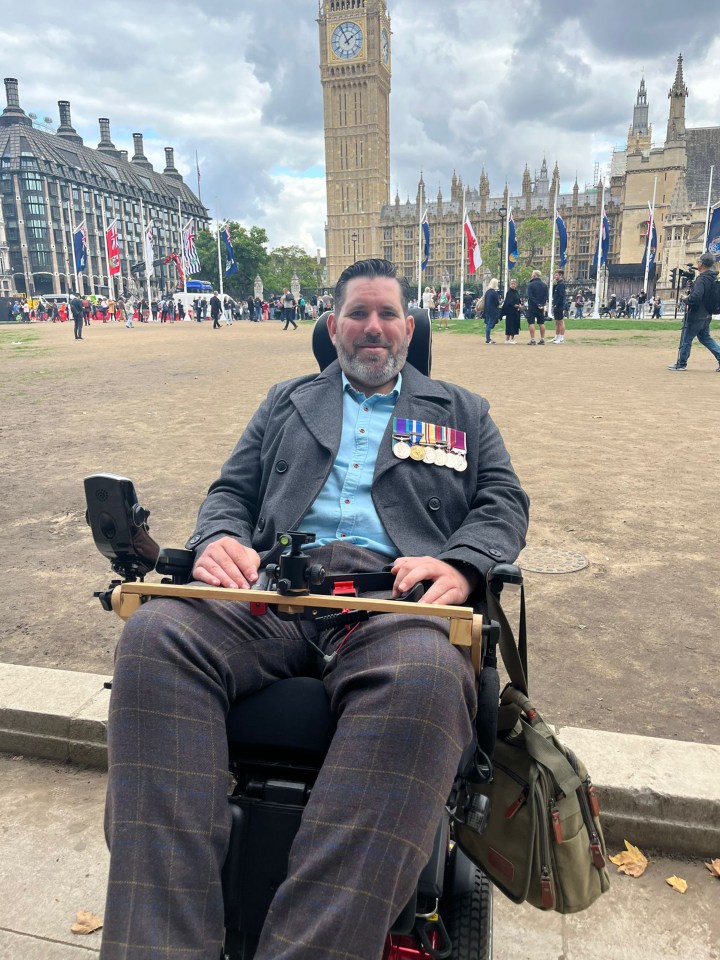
[318,0,720,297]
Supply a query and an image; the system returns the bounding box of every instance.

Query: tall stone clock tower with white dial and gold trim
[318,0,390,284]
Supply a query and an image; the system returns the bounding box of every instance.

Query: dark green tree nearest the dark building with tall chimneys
[196,220,268,297]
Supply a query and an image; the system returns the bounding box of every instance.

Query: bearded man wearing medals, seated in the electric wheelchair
[101,260,528,960]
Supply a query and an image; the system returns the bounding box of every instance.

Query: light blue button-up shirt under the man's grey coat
[302,373,402,560]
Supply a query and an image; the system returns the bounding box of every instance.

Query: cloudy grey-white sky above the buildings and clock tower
[0,0,720,253]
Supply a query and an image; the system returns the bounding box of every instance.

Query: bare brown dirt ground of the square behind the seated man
[0,323,720,743]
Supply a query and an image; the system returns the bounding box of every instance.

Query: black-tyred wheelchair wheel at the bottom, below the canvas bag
[442,847,493,960]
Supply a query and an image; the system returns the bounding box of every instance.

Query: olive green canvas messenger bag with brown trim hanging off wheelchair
[453,576,610,913]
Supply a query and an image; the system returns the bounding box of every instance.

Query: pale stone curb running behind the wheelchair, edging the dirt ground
[0,663,720,859]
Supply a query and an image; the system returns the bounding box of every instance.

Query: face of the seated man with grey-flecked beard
[328,277,415,393]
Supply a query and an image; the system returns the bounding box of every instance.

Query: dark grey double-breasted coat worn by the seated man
[187,361,529,576]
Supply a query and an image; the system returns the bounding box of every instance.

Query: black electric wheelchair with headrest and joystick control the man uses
[85,310,519,960]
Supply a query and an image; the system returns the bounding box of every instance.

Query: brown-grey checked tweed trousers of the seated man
[100,544,475,960]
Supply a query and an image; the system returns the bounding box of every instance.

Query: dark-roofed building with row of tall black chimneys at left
[0,78,209,296]
